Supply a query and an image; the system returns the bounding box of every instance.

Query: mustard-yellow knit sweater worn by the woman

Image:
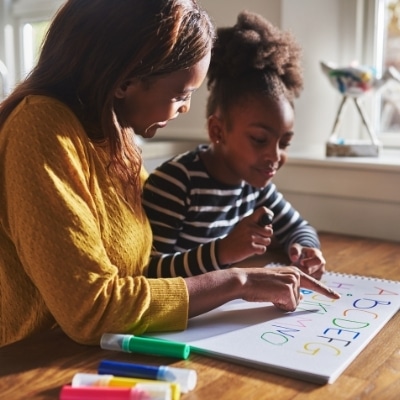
[0,96,188,346]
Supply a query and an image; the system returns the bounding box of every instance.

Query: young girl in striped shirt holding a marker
[143,12,325,278]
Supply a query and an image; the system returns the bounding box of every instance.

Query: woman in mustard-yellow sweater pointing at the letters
[0,0,336,346]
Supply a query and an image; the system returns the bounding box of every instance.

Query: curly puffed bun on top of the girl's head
[208,11,302,95]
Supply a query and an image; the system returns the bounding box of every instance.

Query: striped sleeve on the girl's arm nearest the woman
[143,160,221,277]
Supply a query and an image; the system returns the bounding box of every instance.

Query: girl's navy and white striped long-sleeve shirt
[143,145,320,277]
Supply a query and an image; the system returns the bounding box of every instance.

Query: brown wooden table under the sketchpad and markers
[0,233,400,400]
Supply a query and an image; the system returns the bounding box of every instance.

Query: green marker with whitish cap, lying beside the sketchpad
[100,333,190,360]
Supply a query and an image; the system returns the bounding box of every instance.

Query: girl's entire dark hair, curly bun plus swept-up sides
[206,11,303,119]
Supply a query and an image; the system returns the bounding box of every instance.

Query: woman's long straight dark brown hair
[0,0,214,205]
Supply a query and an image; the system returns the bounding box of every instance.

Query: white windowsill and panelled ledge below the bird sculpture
[274,152,400,242]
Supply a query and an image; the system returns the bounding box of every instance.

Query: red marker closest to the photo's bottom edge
[60,384,171,400]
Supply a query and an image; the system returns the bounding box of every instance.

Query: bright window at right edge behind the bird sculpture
[340,0,400,148]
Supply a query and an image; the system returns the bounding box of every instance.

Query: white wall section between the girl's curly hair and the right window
[282,0,355,151]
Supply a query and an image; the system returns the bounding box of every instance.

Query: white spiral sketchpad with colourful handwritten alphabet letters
[148,273,400,383]
